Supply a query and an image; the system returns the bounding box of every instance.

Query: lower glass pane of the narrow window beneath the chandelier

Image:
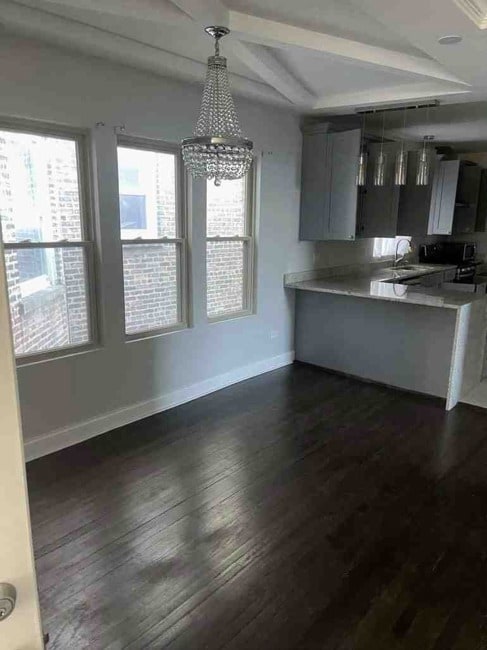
[206,241,247,318]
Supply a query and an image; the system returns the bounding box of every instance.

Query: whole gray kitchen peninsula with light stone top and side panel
[285,264,487,410]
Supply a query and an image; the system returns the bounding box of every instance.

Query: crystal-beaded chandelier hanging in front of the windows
[182,27,253,185]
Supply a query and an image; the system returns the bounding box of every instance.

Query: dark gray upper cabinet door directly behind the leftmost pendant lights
[358,142,400,237]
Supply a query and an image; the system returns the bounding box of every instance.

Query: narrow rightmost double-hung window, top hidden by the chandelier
[206,170,254,321]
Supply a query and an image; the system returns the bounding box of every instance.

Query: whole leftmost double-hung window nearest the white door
[0,127,96,361]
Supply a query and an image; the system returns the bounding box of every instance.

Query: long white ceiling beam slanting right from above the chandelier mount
[229,11,470,84]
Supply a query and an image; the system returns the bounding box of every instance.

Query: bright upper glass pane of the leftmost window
[0,131,82,242]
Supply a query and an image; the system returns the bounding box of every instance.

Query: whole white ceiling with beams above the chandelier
[0,0,487,114]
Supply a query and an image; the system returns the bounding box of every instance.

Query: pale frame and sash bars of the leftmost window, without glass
[0,117,100,367]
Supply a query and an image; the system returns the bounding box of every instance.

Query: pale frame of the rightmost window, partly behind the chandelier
[205,159,257,323]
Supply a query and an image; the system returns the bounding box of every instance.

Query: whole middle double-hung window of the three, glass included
[118,137,187,338]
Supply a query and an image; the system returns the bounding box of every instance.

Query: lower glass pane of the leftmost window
[5,248,90,355]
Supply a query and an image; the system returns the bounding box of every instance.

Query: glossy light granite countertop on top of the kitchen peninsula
[285,264,487,309]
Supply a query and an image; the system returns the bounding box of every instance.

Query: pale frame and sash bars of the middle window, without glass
[117,134,191,343]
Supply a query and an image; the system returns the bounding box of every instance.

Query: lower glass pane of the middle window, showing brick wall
[123,244,181,334]
